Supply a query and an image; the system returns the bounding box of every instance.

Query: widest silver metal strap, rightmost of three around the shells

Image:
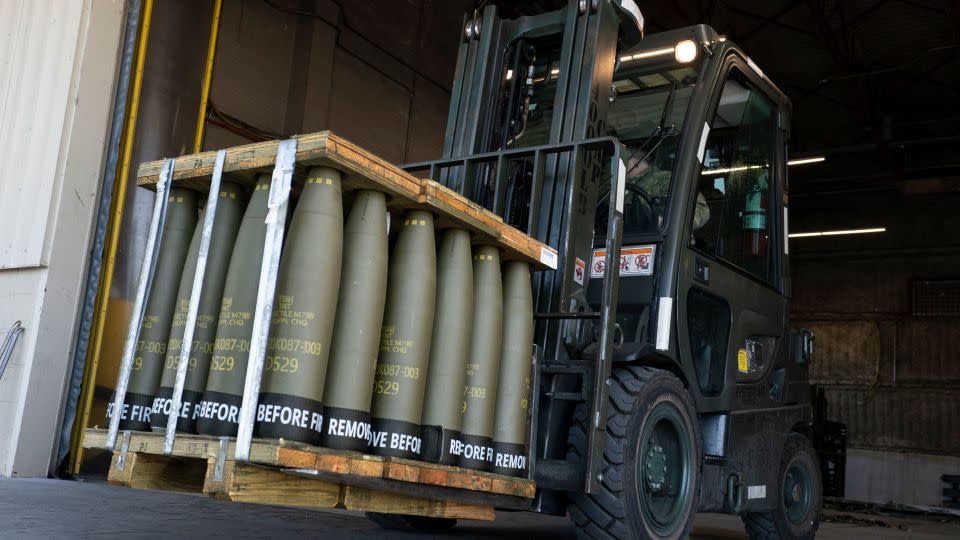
[234,138,297,461]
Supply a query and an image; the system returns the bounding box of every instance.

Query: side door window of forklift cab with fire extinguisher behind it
[690,70,776,283]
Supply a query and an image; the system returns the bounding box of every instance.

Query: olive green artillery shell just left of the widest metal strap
[196,174,270,436]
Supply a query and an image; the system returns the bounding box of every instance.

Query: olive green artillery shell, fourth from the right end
[372,210,437,457]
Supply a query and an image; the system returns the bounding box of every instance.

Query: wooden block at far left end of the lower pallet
[107,452,207,493]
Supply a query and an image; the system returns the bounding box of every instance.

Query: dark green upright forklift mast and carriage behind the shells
[405,0,643,502]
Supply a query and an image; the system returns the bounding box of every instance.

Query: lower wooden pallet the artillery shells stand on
[83,428,536,521]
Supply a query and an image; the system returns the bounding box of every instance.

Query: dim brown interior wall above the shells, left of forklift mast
[204,0,472,162]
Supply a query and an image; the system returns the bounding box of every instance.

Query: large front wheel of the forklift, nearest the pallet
[568,366,701,540]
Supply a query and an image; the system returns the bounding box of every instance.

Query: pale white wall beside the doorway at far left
[0,0,124,476]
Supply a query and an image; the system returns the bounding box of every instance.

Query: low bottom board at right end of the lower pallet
[343,486,496,521]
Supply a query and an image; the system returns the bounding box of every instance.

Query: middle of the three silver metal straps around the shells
[163,150,227,456]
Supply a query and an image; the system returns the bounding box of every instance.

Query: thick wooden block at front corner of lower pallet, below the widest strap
[203,460,341,508]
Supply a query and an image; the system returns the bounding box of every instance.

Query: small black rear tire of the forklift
[742,433,823,540]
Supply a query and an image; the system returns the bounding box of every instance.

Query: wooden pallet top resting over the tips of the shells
[137,131,557,270]
